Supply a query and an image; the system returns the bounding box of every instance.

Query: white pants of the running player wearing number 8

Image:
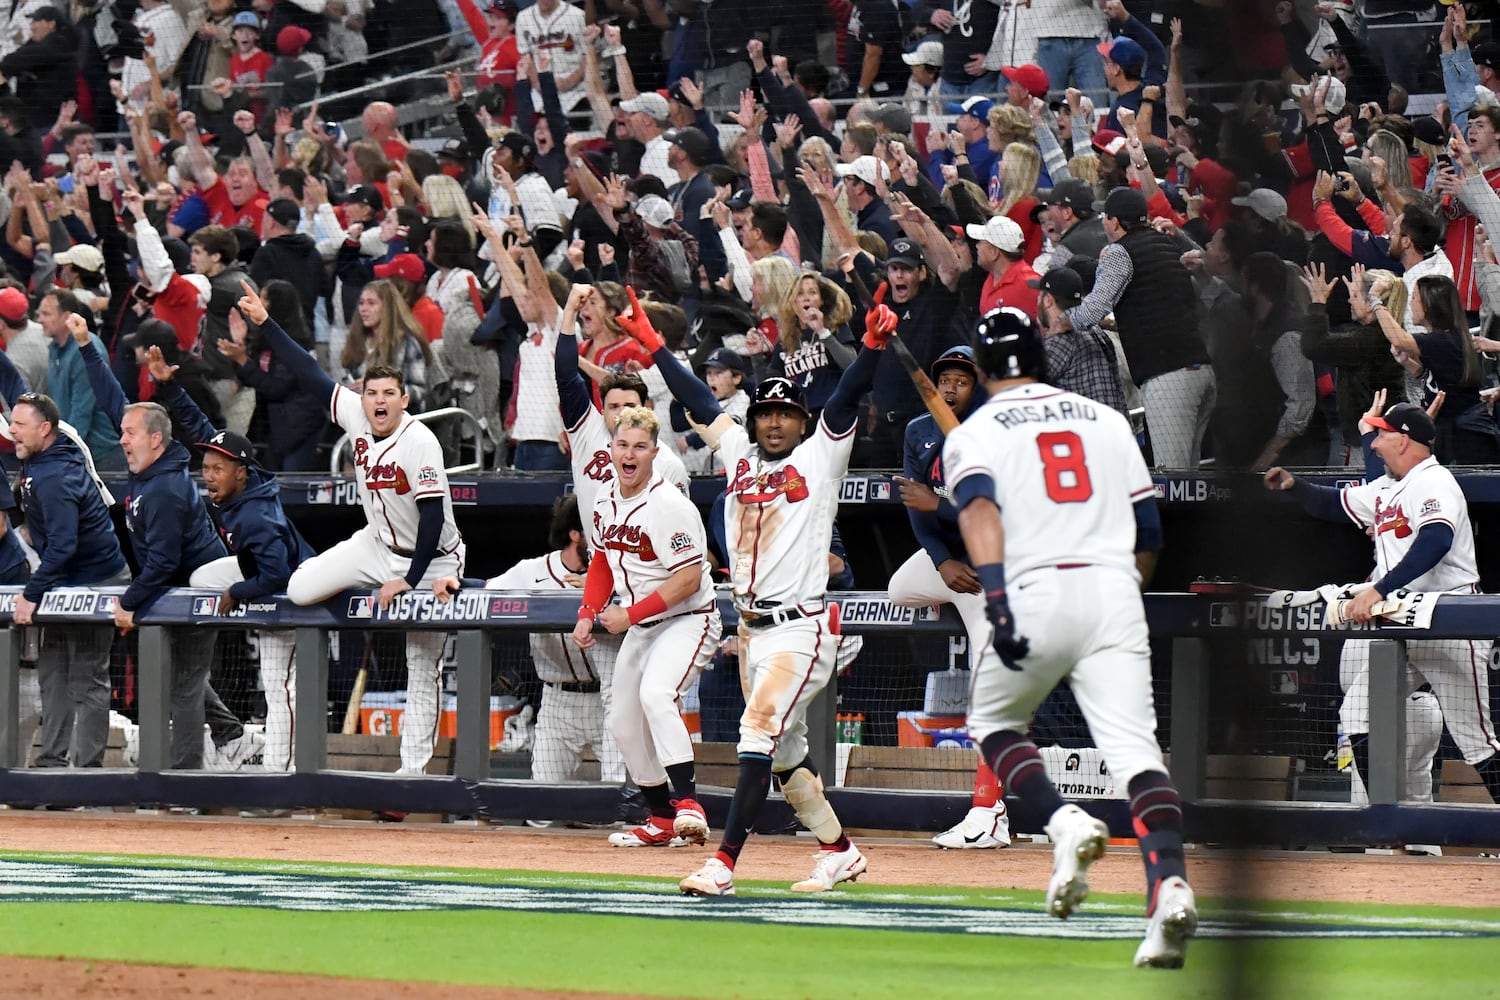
[969,565,1167,786]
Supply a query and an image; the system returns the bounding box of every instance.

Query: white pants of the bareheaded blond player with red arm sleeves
[608,610,723,786]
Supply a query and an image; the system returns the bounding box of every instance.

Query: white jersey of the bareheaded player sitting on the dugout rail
[332,385,461,553]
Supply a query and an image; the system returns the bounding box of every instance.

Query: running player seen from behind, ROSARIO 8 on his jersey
[944,307,1197,969]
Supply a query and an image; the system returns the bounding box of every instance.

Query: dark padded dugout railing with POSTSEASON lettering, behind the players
[0,588,1500,846]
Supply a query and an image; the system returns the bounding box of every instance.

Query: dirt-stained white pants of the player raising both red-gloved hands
[738,610,839,771]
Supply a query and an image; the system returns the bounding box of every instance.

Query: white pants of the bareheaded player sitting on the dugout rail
[287,526,464,774]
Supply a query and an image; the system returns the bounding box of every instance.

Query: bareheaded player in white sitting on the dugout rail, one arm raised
[239,283,465,773]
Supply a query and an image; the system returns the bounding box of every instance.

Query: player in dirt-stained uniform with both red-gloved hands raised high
[621,286,897,897]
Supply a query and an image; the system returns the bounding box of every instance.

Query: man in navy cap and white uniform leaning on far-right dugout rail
[1266,403,1500,802]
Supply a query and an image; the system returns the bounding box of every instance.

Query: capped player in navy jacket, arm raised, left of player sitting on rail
[147,344,317,771]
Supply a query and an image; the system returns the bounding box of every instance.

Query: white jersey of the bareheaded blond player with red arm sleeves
[588,474,714,624]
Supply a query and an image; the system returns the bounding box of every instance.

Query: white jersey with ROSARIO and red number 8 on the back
[944,382,1155,583]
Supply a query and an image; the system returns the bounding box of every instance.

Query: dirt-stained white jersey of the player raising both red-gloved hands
[719,420,854,610]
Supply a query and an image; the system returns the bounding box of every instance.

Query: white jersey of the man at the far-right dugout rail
[1340,456,1479,594]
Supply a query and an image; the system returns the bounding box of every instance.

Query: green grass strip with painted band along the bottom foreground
[0,853,1500,1000]
